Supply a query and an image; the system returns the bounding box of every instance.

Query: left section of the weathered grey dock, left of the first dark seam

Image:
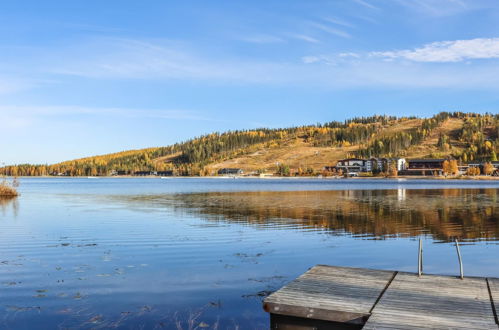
[264,265,395,324]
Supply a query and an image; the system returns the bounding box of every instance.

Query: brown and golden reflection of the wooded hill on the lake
[168,189,499,241]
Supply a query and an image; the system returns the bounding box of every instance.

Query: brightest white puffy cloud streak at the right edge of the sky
[370,38,499,62]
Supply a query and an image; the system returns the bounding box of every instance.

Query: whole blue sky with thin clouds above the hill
[0,0,499,164]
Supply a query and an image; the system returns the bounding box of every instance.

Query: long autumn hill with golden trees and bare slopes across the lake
[0,112,499,176]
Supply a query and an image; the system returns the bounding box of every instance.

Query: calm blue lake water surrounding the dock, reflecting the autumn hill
[0,178,499,329]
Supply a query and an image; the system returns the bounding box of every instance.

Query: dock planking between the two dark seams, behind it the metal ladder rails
[363,273,497,330]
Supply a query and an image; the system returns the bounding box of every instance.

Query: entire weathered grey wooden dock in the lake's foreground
[263,265,499,330]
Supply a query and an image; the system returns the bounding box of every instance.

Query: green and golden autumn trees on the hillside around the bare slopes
[0,112,499,176]
